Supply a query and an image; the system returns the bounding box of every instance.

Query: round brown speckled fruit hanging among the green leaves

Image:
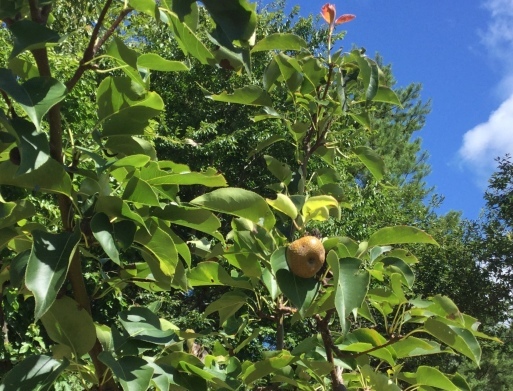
[287,236,326,278]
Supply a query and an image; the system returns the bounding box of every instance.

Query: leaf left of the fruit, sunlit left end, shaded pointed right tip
[187,261,253,290]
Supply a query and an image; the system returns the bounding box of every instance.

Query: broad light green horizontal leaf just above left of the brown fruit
[191,187,276,230]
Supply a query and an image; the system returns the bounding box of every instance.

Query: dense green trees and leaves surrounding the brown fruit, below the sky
[0,0,511,391]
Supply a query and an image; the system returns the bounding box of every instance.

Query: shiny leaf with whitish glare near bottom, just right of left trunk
[118,307,175,345]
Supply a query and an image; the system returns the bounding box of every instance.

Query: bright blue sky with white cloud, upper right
[260,0,513,218]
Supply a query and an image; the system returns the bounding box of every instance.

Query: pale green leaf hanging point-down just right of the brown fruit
[326,251,370,333]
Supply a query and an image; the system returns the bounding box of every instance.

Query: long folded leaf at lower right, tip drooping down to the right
[424,318,481,365]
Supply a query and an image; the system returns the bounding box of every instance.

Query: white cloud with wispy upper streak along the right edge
[458,0,513,185]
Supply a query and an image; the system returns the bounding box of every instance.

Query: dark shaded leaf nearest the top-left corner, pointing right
[9,19,61,58]
